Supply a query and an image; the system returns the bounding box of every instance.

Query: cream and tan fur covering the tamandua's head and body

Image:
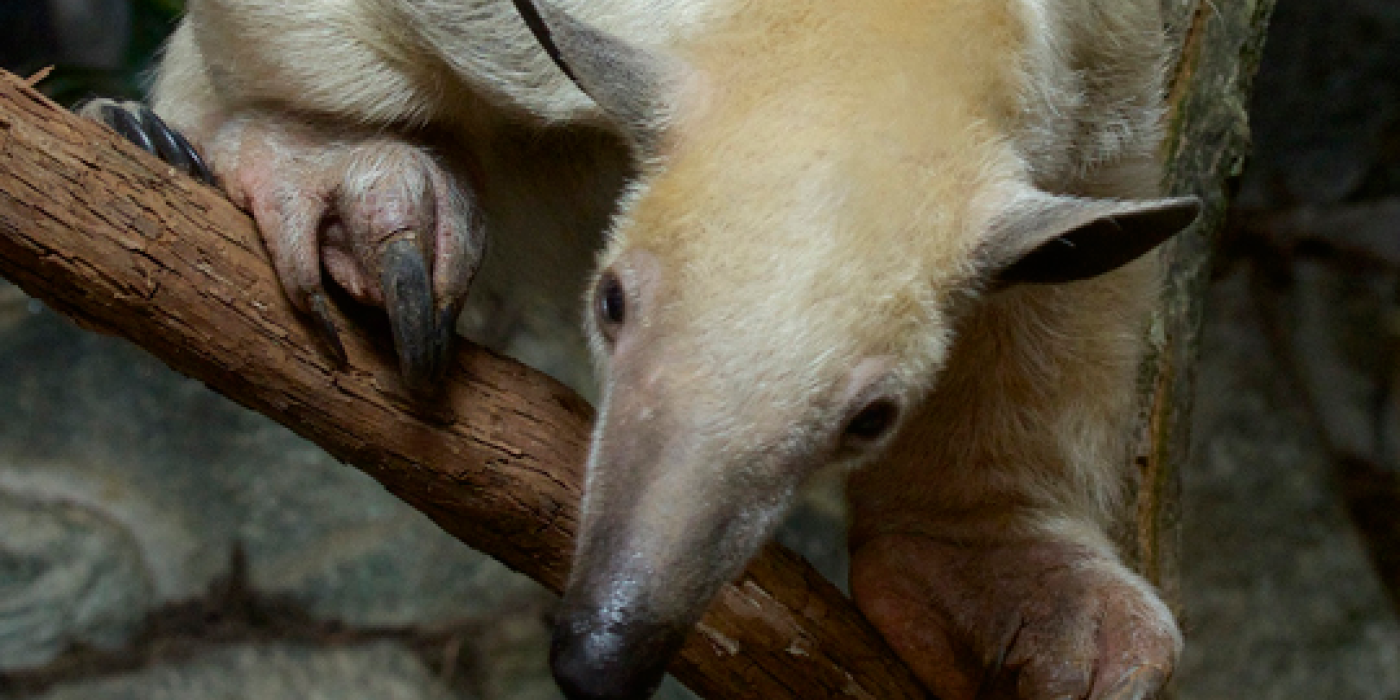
[154,0,1179,697]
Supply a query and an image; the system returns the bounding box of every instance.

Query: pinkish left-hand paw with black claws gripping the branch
[81,99,484,393]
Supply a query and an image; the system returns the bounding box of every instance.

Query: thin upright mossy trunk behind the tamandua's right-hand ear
[1127,0,1274,630]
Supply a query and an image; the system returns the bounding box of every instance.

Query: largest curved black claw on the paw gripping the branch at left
[379,238,448,393]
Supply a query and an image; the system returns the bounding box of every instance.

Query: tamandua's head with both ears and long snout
[517,0,1198,699]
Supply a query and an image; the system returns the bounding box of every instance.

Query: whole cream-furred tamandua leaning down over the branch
[90,0,1200,700]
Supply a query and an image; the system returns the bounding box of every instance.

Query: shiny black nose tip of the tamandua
[549,615,685,700]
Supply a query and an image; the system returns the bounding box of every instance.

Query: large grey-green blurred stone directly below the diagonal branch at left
[0,280,539,660]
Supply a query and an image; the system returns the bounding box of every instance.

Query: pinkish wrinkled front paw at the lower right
[851,535,1182,700]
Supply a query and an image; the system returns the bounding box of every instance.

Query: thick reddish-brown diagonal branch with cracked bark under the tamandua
[0,71,924,700]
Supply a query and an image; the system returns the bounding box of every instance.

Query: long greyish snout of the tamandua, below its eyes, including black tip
[550,365,801,700]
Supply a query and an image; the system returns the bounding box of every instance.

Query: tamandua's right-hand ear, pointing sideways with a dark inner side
[984,193,1201,286]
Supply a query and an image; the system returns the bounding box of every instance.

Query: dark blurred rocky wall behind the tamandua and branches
[0,0,1400,700]
